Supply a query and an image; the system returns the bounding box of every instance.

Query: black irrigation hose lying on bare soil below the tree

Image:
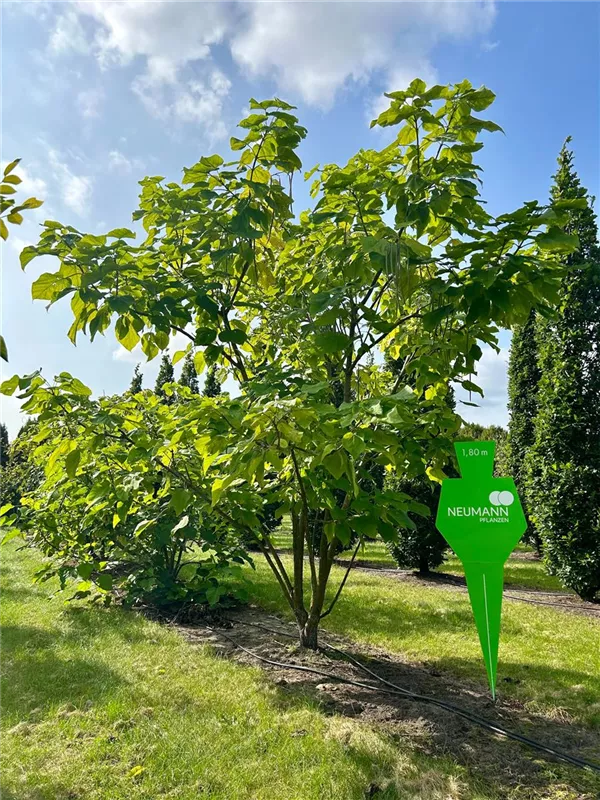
[211,622,600,773]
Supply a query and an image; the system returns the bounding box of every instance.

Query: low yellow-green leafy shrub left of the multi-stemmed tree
[1,384,253,606]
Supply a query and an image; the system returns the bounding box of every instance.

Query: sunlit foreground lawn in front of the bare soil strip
[0,543,502,800]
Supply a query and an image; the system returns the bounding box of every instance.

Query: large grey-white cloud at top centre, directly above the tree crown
[231,0,495,107]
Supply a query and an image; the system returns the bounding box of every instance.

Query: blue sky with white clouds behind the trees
[0,0,600,435]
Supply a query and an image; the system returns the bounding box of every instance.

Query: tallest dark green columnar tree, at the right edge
[526,139,600,600]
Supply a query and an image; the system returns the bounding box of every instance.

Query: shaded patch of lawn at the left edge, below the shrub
[0,625,122,720]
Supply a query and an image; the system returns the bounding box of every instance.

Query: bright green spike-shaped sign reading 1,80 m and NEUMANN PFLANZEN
[435,442,527,699]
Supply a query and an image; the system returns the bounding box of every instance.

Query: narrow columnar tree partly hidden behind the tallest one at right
[508,311,541,553]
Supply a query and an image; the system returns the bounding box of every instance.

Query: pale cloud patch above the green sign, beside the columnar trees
[456,345,510,426]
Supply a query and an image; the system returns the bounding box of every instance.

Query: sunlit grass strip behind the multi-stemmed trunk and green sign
[239,556,600,730]
